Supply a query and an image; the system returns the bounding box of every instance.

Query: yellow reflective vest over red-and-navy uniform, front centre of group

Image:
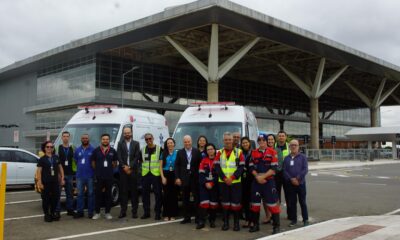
[218,148,242,183]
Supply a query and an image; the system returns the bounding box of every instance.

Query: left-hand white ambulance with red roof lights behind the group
[55,105,169,150]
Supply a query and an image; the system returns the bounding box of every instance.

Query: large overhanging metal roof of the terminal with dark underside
[0,0,400,112]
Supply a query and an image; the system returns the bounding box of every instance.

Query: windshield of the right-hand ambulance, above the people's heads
[174,122,243,149]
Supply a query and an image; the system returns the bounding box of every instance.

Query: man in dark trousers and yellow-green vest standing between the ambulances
[141,133,163,220]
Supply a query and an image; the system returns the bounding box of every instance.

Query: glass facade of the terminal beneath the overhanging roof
[29,54,370,152]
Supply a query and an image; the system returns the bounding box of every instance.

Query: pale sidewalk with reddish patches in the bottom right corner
[259,215,400,240]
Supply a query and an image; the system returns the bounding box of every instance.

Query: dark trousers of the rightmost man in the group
[286,182,308,222]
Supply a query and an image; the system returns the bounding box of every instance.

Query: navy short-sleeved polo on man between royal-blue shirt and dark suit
[91,146,118,179]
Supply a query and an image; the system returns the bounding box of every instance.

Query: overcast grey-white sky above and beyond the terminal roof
[0,0,400,126]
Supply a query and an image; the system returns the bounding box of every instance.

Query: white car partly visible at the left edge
[0,147,39,186]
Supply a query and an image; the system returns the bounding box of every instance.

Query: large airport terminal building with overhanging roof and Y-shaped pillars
[0,0,400,152]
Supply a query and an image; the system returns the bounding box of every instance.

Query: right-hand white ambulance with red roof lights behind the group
[173,102,258,148]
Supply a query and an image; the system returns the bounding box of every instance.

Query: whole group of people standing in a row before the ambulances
[38,127,308,233]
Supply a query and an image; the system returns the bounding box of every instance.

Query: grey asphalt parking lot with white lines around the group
[5,164,400,240]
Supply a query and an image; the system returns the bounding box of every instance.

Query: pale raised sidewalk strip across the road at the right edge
[308,159,400,170]
